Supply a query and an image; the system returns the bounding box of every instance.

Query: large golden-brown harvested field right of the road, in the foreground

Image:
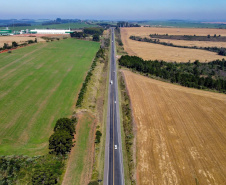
[123,70,226,185]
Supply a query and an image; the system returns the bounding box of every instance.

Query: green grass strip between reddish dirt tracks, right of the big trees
[62,111,95,185]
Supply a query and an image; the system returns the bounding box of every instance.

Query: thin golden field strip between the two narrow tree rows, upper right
[159,39,226,48]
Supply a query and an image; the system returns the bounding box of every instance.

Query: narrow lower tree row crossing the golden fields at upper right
[130,36,226,56]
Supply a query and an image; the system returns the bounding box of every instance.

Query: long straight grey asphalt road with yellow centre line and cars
[104,28,124,185]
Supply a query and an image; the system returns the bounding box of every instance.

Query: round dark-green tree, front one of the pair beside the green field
[49,130,74,155]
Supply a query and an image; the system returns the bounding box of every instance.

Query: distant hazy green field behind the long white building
[0,23,97,31]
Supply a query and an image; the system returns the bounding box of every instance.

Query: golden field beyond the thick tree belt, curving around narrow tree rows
[121,27,226,62]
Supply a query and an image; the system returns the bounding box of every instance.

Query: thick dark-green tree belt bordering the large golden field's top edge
[119,55,226,93]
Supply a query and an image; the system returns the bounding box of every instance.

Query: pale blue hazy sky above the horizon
[0,0,226,21]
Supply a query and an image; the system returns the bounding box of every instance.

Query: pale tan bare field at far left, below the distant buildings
[0,36,45,47]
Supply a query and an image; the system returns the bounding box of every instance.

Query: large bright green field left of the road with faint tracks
[0,39,99,156]
